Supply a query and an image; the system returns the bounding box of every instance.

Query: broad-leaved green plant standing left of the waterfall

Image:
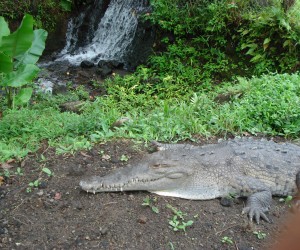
[0,14,47,108]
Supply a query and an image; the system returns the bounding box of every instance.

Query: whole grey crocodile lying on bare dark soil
[80,137,300,223]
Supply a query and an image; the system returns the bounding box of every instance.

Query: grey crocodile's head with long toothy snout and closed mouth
[80,148,194,196]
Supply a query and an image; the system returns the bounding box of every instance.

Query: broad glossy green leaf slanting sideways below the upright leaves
[3,64,40,88]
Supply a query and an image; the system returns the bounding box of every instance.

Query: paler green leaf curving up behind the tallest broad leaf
[15,29,48,68]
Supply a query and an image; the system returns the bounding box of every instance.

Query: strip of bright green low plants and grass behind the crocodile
[0,74,300,162]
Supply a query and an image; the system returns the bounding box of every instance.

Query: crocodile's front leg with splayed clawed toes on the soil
[242,191,272,224]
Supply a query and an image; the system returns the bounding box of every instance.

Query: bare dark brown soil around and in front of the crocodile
[0,140,289,250]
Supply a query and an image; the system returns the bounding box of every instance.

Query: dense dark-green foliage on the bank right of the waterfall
[145,0,300,82]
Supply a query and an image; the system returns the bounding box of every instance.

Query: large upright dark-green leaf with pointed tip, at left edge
[1,14,34,58]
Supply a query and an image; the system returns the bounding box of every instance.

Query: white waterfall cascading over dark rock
[57,0,149,65]
